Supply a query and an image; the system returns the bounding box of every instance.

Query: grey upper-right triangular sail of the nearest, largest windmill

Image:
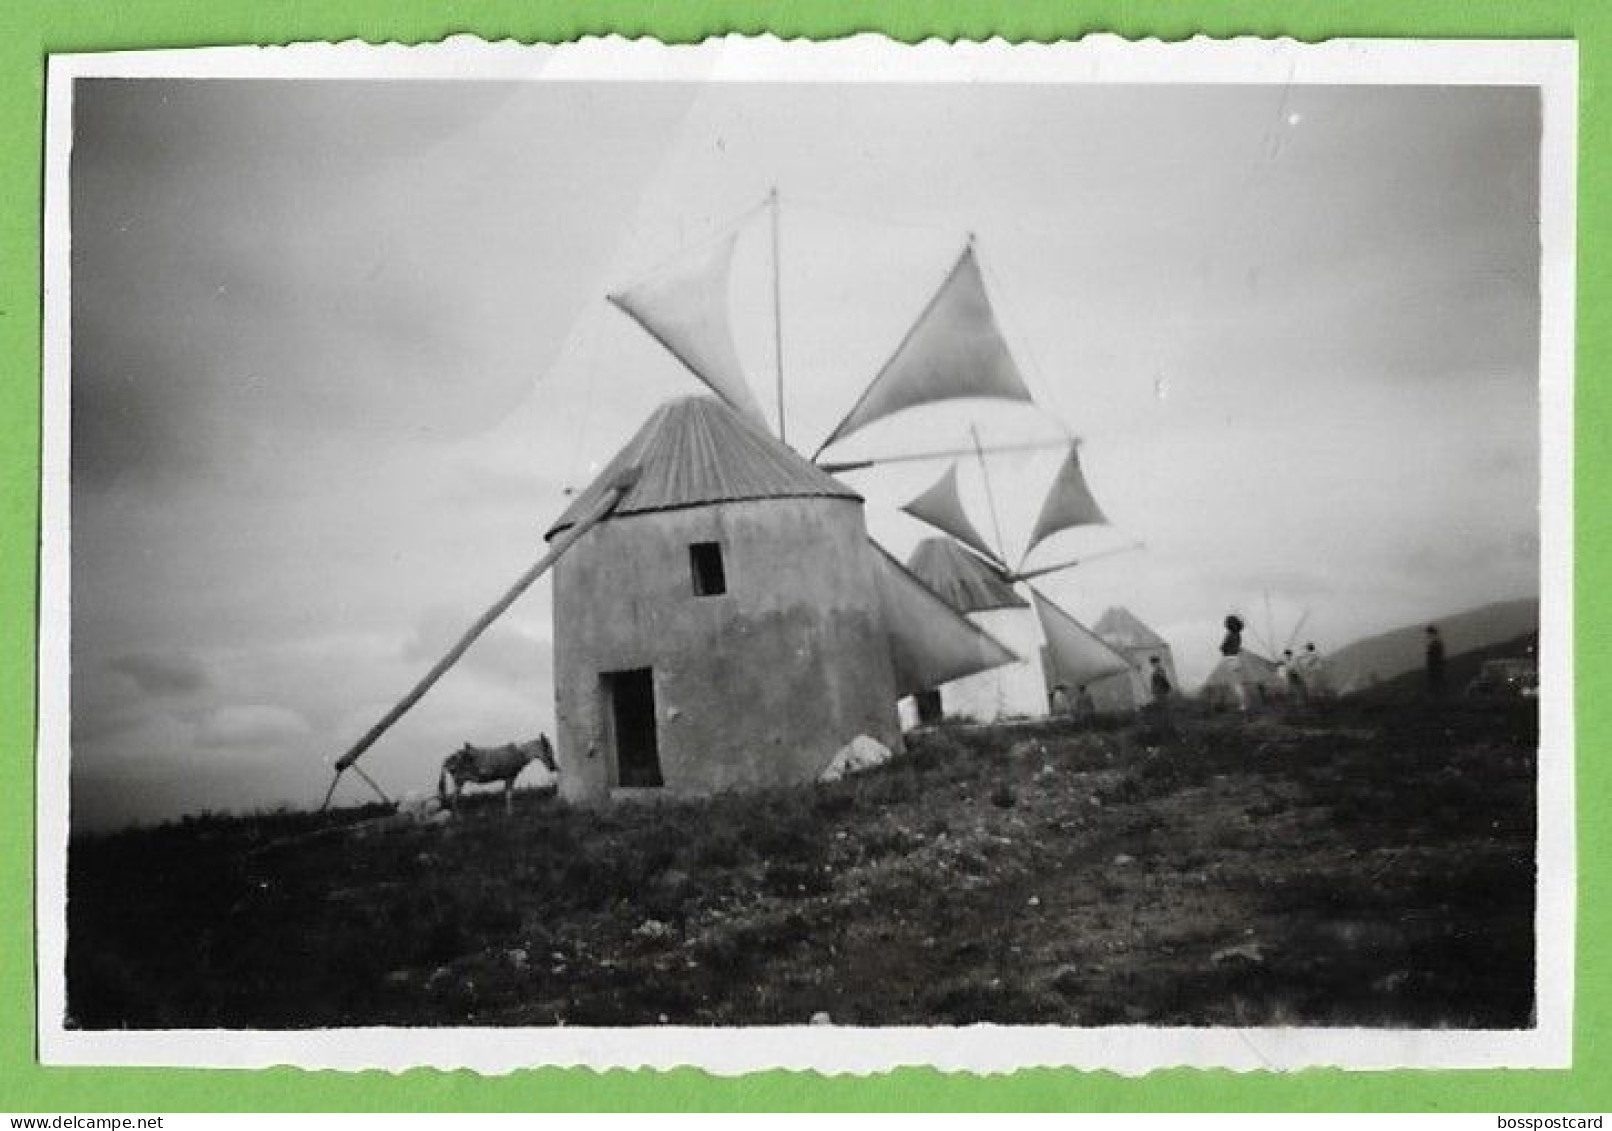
[817,243,1030,453]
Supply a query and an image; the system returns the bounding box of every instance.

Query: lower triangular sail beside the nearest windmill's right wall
[869,541,1019,696]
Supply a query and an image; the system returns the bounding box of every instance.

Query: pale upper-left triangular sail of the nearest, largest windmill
[609,232,766,427]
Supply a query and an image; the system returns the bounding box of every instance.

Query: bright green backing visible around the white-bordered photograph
[0,0,1612,1113]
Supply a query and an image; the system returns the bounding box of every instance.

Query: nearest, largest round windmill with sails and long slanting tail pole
[324,193,1017,806]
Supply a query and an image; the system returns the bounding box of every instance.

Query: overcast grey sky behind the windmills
[73,81,1539,827]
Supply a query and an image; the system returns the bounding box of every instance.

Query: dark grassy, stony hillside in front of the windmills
[68,704,1535,1028]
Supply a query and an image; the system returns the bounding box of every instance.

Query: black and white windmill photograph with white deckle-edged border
[39,37,1573,1070]
